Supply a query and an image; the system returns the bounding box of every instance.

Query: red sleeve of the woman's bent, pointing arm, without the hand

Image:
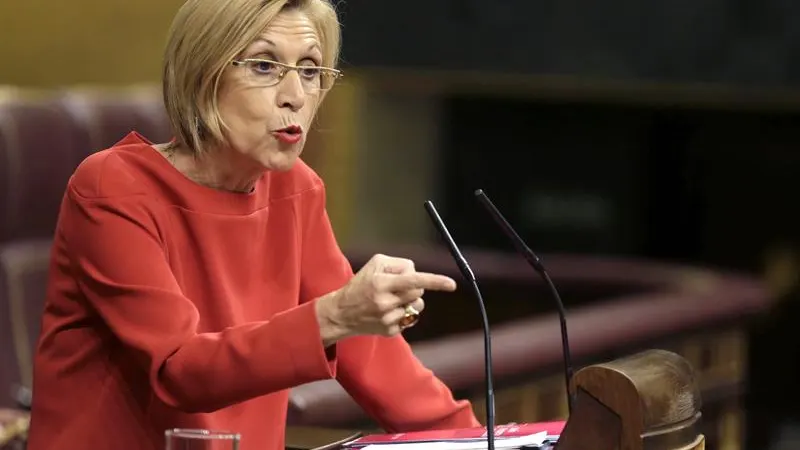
[59,184,336,412]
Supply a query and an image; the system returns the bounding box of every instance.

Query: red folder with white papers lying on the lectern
[344,421,566,448]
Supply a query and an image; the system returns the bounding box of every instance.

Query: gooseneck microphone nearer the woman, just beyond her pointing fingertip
[425,200,495,450]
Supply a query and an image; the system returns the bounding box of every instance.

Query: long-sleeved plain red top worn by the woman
[28,133,478,450]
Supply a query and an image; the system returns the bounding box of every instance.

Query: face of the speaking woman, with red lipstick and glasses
[218,10,322,171]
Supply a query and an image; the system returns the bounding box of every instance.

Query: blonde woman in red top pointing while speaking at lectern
[29,0,478,450]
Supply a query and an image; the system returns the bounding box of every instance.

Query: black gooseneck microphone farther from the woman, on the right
[475,189,573,413]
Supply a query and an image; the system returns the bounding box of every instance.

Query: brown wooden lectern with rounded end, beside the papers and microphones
[286,350,705,450]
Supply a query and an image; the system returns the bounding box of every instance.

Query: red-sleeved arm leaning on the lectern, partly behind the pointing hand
[302,184,481,431]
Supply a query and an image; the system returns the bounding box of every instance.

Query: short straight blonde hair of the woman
[162,0,341,155]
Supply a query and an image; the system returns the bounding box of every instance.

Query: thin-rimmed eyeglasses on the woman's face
[231,58,343,92]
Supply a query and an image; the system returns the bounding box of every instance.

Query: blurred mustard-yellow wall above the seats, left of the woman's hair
[0,0,183,87]
